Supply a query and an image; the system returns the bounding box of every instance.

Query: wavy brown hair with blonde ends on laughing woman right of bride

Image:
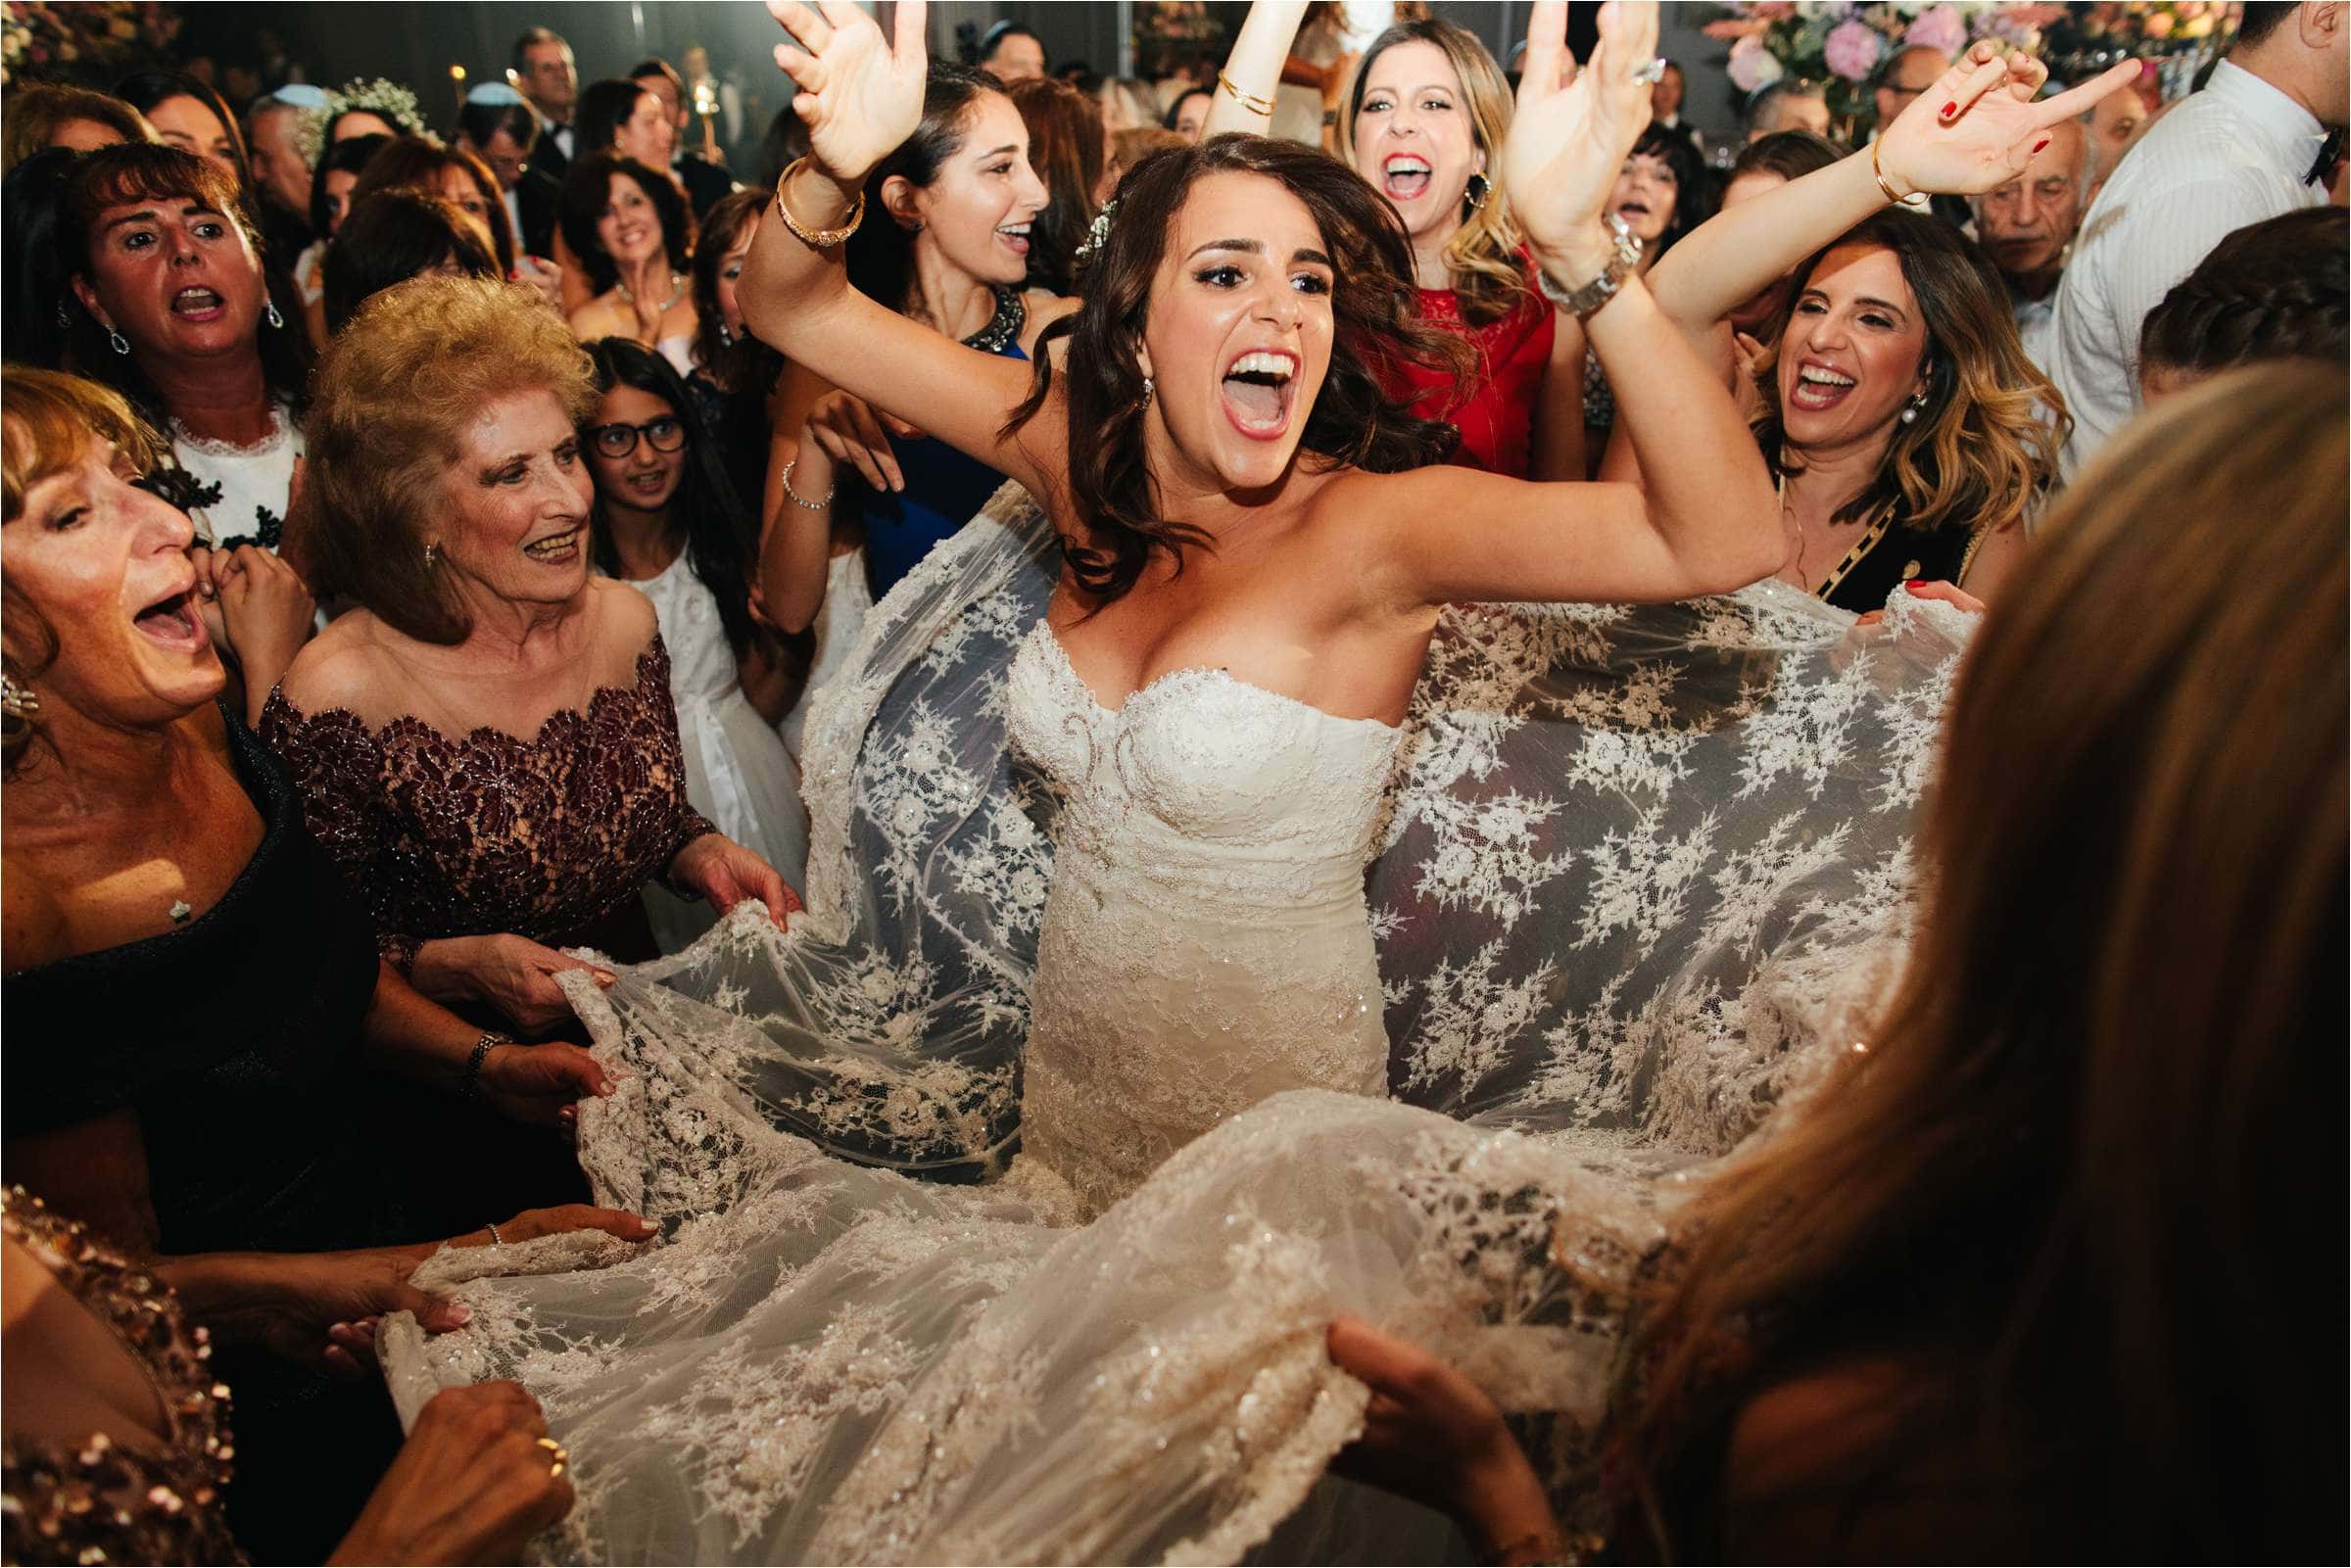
[1756,210,2074,531]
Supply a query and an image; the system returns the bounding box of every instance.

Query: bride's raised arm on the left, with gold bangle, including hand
[741,0,1068,496]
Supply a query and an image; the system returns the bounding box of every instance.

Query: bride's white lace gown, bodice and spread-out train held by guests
[383,489,1965,1561]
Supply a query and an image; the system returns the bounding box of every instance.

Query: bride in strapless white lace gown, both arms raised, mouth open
[386,2,2116,1561]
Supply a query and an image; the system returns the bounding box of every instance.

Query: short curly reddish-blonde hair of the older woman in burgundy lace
[289,277,598,644]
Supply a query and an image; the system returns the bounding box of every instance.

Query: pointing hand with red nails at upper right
[1876,37,2139,195]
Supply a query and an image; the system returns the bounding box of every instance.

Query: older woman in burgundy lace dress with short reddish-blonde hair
[264,277,799,1029]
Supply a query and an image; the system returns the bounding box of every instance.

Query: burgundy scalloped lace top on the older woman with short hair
[261,635,715,971]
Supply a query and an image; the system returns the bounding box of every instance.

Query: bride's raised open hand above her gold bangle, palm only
[766,0,931,186]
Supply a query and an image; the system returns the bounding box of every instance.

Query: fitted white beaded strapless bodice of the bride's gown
[1006,621,1401,1211]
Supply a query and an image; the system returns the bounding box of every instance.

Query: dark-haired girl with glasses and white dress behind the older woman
[581,339,809,952]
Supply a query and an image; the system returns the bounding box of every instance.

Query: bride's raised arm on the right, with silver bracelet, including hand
[1366,0,1787,604]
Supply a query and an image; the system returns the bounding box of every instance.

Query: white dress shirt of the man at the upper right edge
[2043,61,2326,480]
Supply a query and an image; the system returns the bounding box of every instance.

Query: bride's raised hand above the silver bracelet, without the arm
[1503,0,1657,257]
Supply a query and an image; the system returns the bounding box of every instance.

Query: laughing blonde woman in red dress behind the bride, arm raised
[1204,0,1585,480]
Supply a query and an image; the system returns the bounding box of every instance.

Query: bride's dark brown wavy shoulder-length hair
[1004,136,1471,601]
